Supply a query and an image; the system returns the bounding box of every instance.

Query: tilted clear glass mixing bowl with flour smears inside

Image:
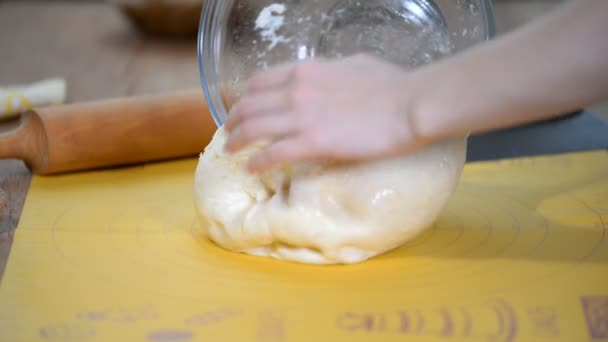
[198,0,494,126]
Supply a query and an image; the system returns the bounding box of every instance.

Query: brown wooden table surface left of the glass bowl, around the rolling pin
[0,1,200,279]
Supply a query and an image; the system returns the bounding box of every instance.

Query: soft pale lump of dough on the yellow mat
[195,128,466,264]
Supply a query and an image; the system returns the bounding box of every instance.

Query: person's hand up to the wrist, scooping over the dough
[225,55,423,172]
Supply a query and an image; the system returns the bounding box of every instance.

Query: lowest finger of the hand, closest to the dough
[247,138,320,173]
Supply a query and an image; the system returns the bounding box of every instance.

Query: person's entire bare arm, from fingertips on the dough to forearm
[225,0,608,172]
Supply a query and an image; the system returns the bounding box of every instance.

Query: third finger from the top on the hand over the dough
[225,114,296,152]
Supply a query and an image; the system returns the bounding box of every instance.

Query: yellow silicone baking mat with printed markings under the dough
[0,151,608,342]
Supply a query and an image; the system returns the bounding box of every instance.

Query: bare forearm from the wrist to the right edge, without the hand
[407,0,608,139]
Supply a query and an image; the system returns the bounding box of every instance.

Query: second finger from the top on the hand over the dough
[226,90,289,132]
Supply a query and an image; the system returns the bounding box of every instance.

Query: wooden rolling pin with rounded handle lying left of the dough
[0,90,217,175]
